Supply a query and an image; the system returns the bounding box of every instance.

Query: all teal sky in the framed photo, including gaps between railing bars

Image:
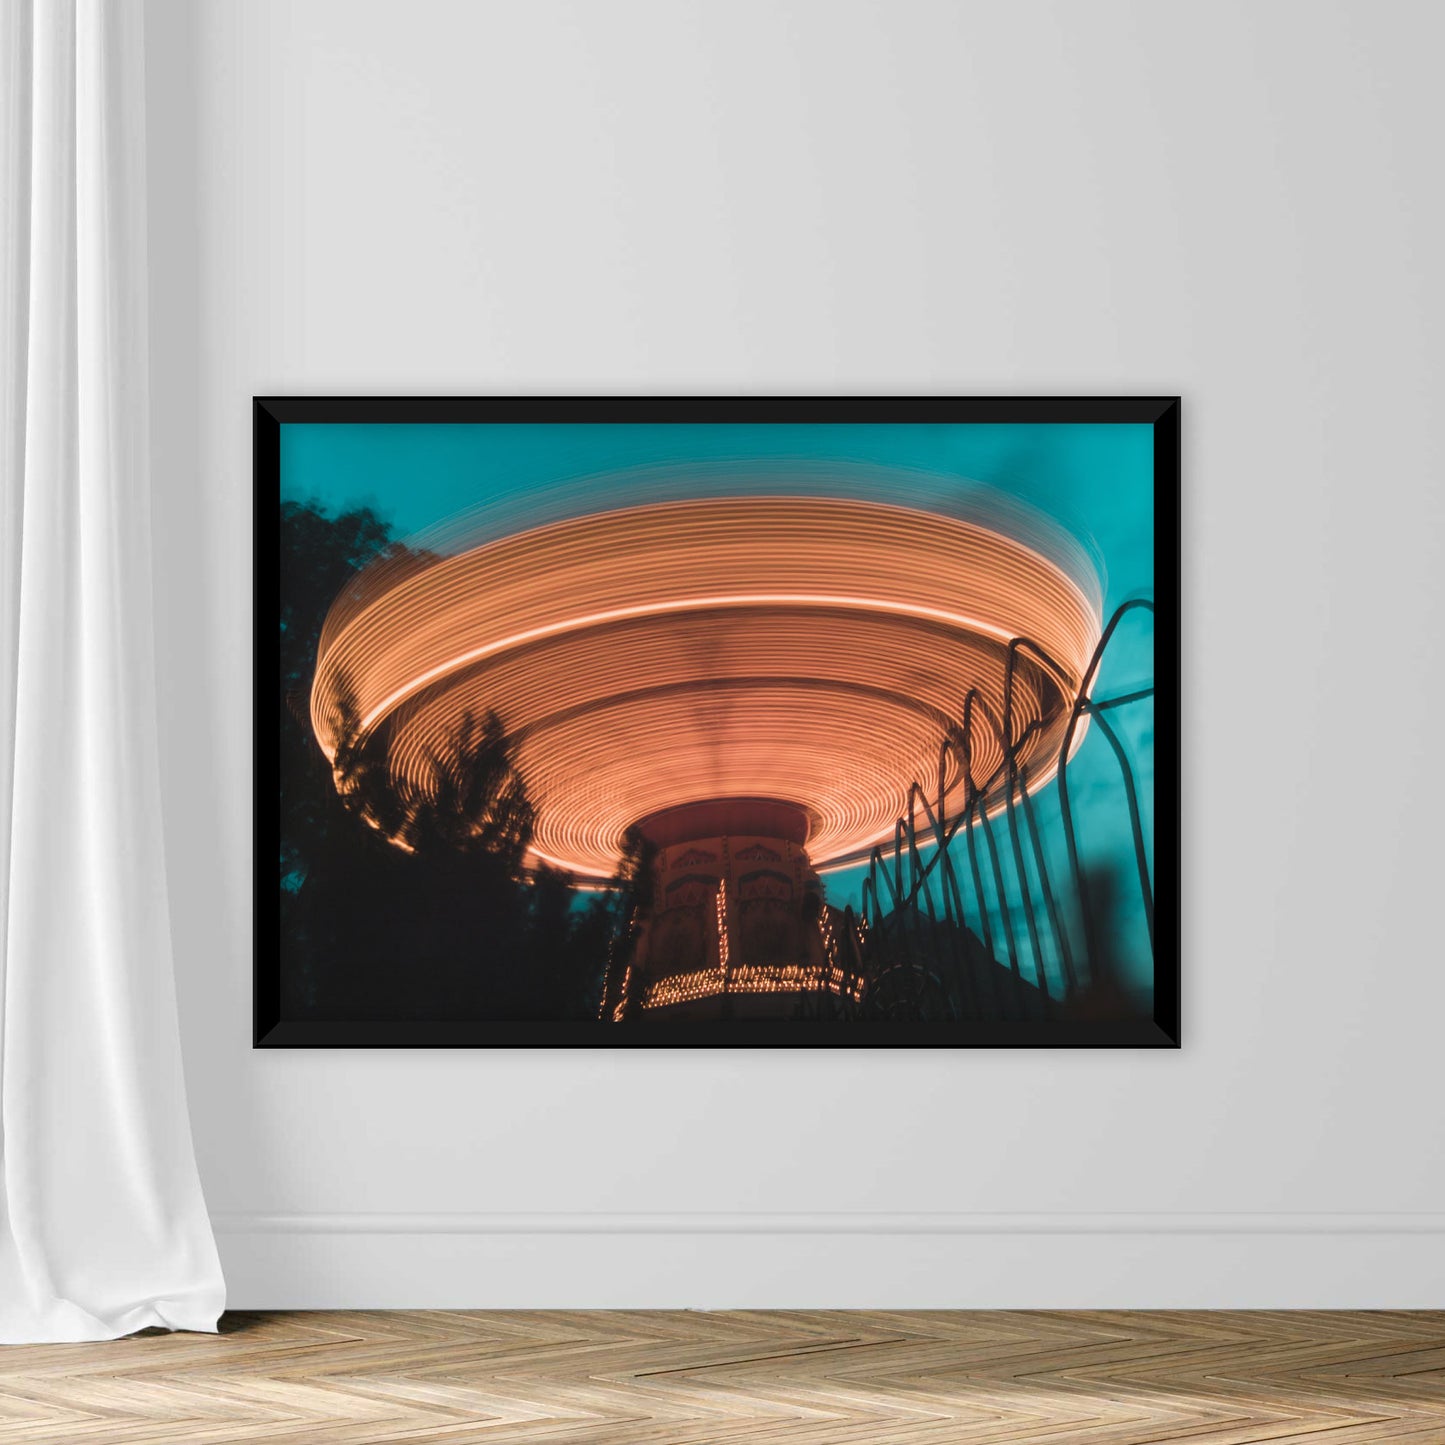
[280,423,1155,987]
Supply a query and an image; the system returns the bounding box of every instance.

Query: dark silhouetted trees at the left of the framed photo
[280,503,618,1019]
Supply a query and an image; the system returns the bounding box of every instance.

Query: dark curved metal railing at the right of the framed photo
[824,600,1155,1020]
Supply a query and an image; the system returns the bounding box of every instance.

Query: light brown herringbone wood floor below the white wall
[0,1311,1445,1445]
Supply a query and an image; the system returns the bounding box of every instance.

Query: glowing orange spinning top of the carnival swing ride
[311,496,1100,879]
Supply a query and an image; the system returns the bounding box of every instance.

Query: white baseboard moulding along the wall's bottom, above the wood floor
[214,1214,1445,1309]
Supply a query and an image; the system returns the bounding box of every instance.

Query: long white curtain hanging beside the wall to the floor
[0,0,224,1341]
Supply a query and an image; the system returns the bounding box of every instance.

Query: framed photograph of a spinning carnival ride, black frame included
[253,397,1179,1048]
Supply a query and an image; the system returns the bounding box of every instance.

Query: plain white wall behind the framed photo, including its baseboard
[149,0,1445,1306]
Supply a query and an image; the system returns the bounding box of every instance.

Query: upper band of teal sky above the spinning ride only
[280,423,1153,611]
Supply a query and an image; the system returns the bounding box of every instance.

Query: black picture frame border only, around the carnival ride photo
[251,396,1181,1049]
